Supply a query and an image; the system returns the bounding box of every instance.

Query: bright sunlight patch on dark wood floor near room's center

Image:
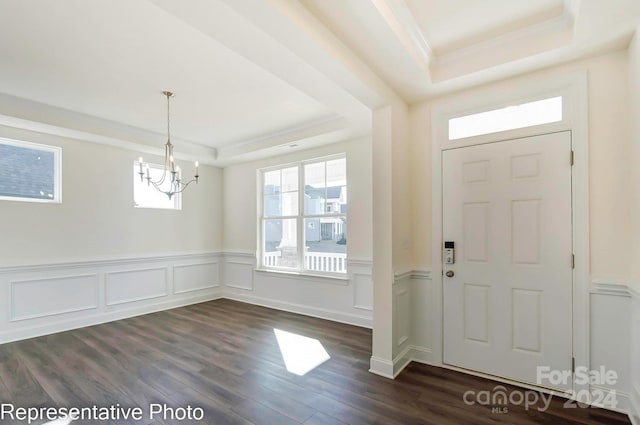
[273,329,331,376]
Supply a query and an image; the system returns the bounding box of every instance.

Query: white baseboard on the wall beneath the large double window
[223,292,373,329]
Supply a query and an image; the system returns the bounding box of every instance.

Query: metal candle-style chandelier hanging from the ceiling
[138,91,200,199]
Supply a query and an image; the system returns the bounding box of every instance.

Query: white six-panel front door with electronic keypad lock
[442,131,573,390]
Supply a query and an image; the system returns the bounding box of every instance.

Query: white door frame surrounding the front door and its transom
[430,72,590,392]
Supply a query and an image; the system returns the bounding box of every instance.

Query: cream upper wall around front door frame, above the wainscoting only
[410,51,631,281]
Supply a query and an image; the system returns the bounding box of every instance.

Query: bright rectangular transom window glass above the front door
[449,96,562,140]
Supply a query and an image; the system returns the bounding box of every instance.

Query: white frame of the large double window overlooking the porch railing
[257,153,349,279]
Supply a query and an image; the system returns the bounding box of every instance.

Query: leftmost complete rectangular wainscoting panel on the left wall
[11,273,98,321]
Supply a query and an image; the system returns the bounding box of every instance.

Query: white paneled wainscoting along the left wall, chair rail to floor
[0,253,222,344]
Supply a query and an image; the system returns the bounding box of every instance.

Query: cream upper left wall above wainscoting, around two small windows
[0,122,222,267]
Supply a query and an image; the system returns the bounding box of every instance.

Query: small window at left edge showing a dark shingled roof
[0,139,62,202]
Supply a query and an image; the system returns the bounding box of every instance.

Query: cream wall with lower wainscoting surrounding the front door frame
[394,47,640,410]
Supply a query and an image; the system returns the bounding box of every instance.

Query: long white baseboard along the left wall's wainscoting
[0,289,222,344]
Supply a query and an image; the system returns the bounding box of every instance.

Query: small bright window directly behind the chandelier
[133,161,182,210]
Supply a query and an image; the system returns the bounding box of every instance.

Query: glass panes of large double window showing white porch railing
[260,156,347,274]
